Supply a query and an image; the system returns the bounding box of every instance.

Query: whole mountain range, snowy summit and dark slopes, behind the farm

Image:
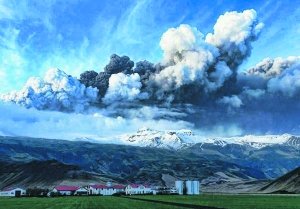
[0,128,300,191]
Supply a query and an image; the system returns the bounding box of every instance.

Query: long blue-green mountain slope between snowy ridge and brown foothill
[0,137,265,187]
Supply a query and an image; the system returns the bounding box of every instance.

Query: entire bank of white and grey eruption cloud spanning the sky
[2,10,300,136]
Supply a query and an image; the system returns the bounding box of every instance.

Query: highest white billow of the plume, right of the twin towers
[205,9,264,69]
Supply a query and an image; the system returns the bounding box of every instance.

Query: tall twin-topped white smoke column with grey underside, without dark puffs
[153,10,263,102]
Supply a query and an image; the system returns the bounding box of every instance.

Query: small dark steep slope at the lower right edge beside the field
[261,167,300,193]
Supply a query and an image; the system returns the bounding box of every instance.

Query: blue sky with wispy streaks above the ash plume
[0,0,300,92]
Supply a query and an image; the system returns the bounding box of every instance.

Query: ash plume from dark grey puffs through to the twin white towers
[80,10,263,104]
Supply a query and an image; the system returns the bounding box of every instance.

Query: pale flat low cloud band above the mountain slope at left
[0,103,192,140]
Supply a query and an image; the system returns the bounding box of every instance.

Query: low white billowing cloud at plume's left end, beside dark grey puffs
[1,68,98,112]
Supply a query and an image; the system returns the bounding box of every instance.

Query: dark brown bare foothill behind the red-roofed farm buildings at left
[0,160,104,189]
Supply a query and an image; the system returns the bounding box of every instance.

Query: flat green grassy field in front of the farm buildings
[0,195,300,209]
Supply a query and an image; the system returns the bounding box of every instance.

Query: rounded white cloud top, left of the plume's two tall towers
[154,25,218,91]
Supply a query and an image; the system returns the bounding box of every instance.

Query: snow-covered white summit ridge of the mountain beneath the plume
[121,128,300,150]
